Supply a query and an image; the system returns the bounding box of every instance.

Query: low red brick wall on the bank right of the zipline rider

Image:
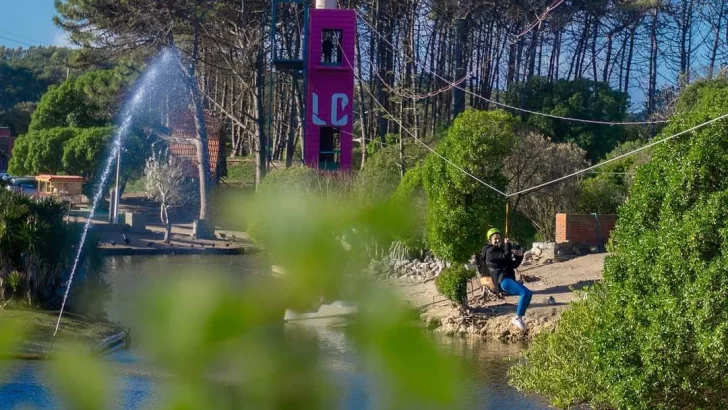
[556,214,617,246]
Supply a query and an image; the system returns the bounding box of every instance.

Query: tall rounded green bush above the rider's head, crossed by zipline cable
[423,110,519,262]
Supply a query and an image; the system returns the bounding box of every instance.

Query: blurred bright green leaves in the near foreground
[0,185,464,410]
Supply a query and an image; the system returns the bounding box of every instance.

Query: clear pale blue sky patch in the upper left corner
[0,0,67,48]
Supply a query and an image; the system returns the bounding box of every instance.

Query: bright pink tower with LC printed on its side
[304,0,356,171]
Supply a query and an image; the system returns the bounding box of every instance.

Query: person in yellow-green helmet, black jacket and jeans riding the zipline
[481,228,533,331]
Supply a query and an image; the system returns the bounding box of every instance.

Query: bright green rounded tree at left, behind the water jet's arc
[9,64,151,191]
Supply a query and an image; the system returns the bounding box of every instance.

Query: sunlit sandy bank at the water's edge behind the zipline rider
[390,254,607,341]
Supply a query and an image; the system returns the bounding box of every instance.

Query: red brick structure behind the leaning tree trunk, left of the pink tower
[168,110,227,181]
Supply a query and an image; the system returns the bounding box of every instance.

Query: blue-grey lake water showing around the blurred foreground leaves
[0,256,550,410]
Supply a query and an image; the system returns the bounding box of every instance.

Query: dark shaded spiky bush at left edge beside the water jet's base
[0,190,109,315]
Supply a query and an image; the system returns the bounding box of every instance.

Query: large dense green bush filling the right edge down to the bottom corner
[512,81,728,409]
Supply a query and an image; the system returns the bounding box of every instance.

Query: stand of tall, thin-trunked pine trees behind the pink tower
[45,0,728,171]
